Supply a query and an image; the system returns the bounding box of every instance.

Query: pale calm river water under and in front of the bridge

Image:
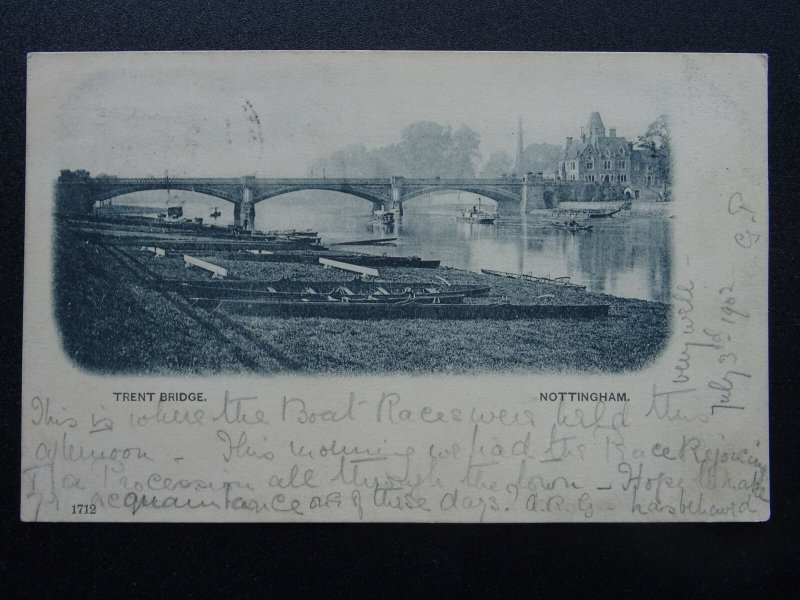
[101,191,672,302]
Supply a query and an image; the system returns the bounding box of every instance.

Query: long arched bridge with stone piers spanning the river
[56,170,585,228]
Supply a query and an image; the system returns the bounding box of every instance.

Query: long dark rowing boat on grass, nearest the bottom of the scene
[193,298,609,320]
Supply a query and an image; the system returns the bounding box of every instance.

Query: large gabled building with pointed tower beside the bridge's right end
[558,112,664,200]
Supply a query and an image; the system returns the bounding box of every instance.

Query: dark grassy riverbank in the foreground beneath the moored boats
[54,216,670,374]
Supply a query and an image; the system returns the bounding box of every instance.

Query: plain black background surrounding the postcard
[0,0,800,598]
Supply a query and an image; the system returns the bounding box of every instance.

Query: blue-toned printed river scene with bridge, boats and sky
[45,53,675,374]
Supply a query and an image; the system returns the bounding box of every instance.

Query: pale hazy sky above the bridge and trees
[39,52,674,177]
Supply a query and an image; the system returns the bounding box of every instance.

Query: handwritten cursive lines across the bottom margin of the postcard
[22,388,769,522]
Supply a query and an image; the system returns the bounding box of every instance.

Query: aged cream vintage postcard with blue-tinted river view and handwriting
[20,51,770,523]
